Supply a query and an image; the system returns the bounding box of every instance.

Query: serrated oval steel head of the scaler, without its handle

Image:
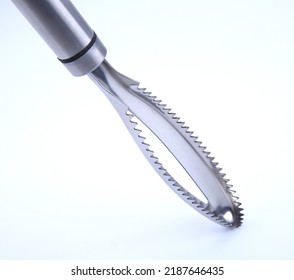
[89,61,243,228]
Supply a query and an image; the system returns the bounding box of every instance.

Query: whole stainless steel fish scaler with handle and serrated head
[12,0,243,228]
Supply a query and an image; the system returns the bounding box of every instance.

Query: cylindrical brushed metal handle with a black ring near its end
[12,0,106,76]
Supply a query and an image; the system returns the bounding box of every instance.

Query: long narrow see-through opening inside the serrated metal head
[132,114,208,203]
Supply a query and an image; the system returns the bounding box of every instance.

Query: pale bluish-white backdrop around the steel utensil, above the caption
[0,0,294,259]
